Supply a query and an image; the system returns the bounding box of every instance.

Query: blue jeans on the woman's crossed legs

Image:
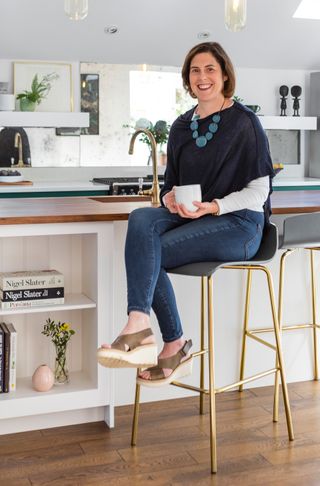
[125,207,264,342]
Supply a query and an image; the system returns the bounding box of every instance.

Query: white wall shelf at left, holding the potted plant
[0,111,89,128]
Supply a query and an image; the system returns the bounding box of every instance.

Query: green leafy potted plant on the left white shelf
[17,73,59,111]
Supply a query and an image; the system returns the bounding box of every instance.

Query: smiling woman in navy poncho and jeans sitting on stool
[98,42,274,386]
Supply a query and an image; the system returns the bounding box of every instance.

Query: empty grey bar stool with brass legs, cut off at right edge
[240,213,320,420]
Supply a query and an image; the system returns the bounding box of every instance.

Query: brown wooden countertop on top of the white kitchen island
[0,191,320,225]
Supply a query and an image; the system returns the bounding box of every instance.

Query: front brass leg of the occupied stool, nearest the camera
[207,275,217,473]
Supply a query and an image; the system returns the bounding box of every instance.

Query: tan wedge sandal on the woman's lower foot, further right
[137,339,193,387]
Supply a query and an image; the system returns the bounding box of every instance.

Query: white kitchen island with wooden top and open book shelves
[0,191,320,434]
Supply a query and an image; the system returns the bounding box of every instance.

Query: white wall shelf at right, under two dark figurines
[259,116,317,130]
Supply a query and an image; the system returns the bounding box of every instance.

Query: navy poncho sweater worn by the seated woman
[161,102,274,218]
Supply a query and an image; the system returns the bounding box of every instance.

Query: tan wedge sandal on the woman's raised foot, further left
[97,328,158,368]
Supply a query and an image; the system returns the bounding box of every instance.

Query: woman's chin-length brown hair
[181,42,236,98]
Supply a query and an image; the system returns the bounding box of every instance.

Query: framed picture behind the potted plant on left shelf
[13,61,73,112]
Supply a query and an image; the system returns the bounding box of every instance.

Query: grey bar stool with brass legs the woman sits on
[131,224,294,473]
